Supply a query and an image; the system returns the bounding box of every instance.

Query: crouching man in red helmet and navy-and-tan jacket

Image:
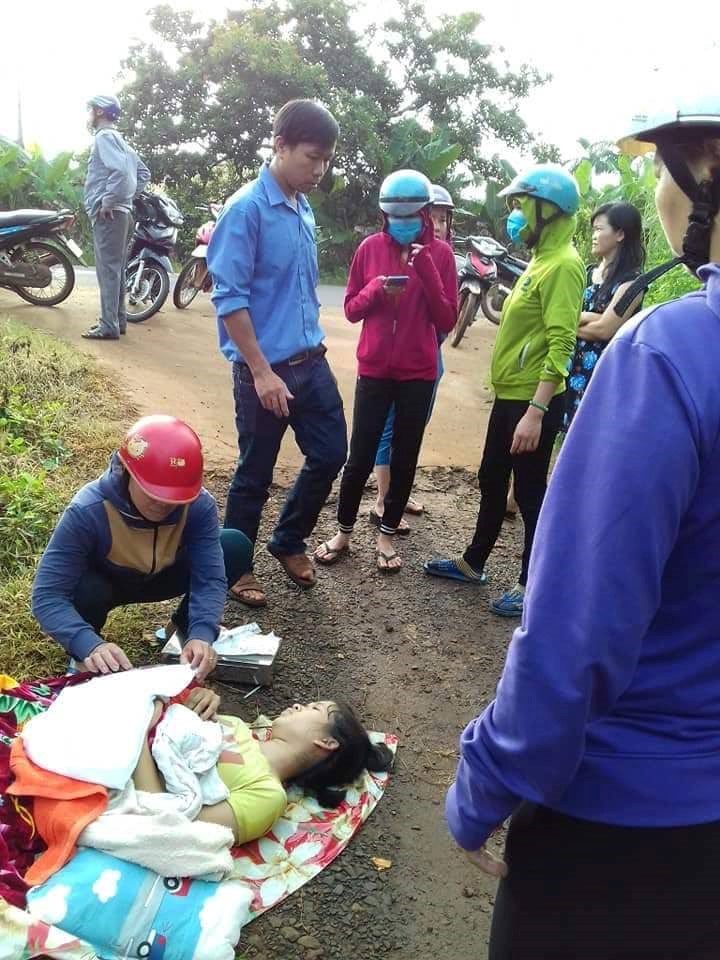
[32,415,252,679]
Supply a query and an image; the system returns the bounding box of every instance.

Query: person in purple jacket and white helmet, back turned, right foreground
[446,95,720,960]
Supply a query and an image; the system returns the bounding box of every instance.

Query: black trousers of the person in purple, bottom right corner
[490,804,720,960]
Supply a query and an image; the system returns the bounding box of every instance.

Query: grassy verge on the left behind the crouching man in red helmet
[0,321,174,680]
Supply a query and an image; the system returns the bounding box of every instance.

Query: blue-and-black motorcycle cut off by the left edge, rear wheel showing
[0,210,83,307]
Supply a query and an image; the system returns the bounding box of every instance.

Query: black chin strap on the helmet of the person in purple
[615,144,720,317]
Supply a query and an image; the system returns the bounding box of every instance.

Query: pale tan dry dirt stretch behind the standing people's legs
[0,287,495,468]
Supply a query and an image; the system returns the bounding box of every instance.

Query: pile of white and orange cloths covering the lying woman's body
[8,666,233,884]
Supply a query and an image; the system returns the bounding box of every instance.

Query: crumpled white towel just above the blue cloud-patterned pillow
[77,783,233,880]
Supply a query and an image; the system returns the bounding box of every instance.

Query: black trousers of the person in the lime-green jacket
[464,396,564,586]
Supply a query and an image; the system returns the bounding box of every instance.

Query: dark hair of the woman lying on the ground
[292,701,393,809]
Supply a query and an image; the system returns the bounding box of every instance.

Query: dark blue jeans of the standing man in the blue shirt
[225,354,347,556]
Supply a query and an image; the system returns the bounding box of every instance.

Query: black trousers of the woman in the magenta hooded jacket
[338,377,435,534]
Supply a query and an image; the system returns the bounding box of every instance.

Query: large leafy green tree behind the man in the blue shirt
[122,0,544,272]
